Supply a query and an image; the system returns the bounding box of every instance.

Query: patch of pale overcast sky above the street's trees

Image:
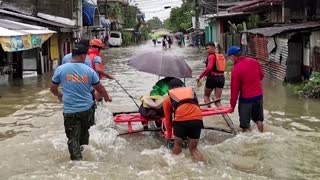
[130,0,182,21]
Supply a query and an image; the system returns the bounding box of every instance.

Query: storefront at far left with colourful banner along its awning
[0,19,56,79]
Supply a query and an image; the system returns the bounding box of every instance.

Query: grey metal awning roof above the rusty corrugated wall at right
[243,22,320,37]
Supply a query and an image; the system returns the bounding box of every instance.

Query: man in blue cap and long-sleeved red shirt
[228,46,264,132]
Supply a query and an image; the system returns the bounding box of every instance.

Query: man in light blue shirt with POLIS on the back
[50,44,112,160]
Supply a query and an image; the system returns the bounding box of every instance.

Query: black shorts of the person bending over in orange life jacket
[173,120,203,139]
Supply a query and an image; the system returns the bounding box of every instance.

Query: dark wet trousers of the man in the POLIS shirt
[63,108,94,160]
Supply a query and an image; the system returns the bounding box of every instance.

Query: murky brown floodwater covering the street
[0,42,320,180]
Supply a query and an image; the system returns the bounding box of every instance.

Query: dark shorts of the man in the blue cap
[238,100,264,129]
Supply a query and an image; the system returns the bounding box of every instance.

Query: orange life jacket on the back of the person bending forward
[168,87,199,119]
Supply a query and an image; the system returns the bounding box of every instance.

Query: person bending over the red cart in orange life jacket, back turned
[163,78,204,161]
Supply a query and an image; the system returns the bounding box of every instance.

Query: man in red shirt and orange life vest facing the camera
[197,42,225,103]
